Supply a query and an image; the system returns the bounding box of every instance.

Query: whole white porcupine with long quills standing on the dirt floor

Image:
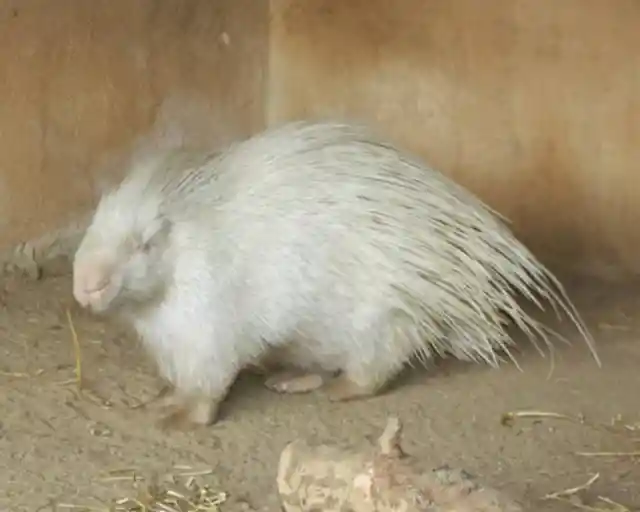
[74,121,599,424]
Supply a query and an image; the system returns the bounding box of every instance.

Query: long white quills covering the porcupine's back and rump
[102,122,599,374]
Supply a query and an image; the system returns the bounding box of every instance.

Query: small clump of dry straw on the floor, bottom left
[56,466,227,512]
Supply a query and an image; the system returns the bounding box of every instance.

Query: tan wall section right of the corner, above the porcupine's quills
[268,0,640,277]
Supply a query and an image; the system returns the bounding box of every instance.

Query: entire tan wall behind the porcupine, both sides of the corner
[0,0,640,277]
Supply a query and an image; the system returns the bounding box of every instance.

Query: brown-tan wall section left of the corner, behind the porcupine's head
[0,0,268,270]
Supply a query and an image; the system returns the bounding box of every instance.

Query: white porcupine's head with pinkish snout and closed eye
[73,157,170,314]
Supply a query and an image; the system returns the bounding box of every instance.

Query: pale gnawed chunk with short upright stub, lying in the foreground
[277,418,524,512]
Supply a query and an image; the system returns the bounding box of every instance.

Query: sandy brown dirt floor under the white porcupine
[0,277,640,512]
